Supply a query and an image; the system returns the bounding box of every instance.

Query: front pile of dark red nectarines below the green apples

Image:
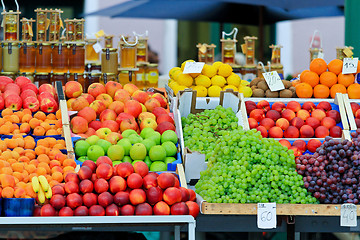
[39,157,199,217]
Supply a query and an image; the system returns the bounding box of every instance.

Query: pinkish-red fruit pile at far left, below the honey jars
[0,76,58,113]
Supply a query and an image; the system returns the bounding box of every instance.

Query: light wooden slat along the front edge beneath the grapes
[201,202,360,216]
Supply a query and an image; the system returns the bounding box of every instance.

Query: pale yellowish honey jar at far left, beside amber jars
[2,42,19,72]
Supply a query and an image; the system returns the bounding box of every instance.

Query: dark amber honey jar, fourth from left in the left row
[52,43,69,73]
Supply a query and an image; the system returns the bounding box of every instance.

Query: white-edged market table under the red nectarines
[0,215,196,240]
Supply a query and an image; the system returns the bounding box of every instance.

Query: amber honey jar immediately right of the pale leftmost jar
[19,42,36,72]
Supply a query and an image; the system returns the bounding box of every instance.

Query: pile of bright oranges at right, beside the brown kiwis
[293,58,360,99]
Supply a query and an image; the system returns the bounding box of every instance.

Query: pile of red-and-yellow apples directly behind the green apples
[65,81,175,138]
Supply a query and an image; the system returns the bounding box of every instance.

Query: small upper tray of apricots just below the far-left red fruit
[0,108,62,136]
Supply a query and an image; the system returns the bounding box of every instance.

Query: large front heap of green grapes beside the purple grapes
[195,127,317,203]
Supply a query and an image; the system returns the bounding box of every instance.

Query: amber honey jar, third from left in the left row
[35,43,52,73]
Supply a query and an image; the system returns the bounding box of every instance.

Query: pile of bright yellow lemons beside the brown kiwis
[168,60,252,97]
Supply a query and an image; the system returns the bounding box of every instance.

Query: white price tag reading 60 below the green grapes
[257,203,276,229]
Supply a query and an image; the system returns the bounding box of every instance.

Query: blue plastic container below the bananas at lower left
[3,198,35,217]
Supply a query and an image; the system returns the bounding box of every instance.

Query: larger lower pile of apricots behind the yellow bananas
[0,134,76,198]
